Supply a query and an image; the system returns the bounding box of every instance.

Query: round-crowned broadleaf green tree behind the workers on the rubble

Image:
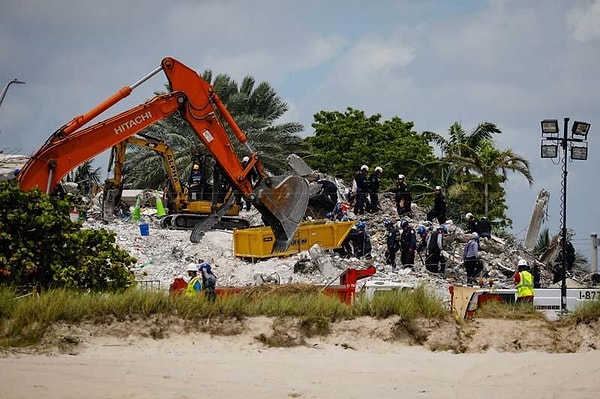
[305,108,435,189]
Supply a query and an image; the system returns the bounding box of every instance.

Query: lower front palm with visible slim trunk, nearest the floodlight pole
[450,140,533,217]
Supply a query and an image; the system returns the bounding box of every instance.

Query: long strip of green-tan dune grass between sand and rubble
[0,284,448,347]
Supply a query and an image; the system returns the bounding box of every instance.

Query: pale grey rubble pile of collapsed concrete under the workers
[83,188,592,304]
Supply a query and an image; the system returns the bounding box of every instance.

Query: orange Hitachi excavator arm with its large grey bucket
[17,57,309,252]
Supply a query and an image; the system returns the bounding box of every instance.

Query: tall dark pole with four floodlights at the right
[541,118,591,312]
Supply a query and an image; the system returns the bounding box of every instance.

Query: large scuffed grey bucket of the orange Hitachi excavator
[253,176,309,252]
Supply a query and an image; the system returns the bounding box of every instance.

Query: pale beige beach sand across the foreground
[0,318,600,399]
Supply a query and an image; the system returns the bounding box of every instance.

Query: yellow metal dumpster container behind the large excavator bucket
[233,220,356,258]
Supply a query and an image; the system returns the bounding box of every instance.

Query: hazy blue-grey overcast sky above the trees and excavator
[0,0,600,256]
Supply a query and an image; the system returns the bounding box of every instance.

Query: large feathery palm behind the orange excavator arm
[124,71,305,188]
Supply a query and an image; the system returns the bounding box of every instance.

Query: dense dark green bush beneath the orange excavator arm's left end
[0,181,136,290]
